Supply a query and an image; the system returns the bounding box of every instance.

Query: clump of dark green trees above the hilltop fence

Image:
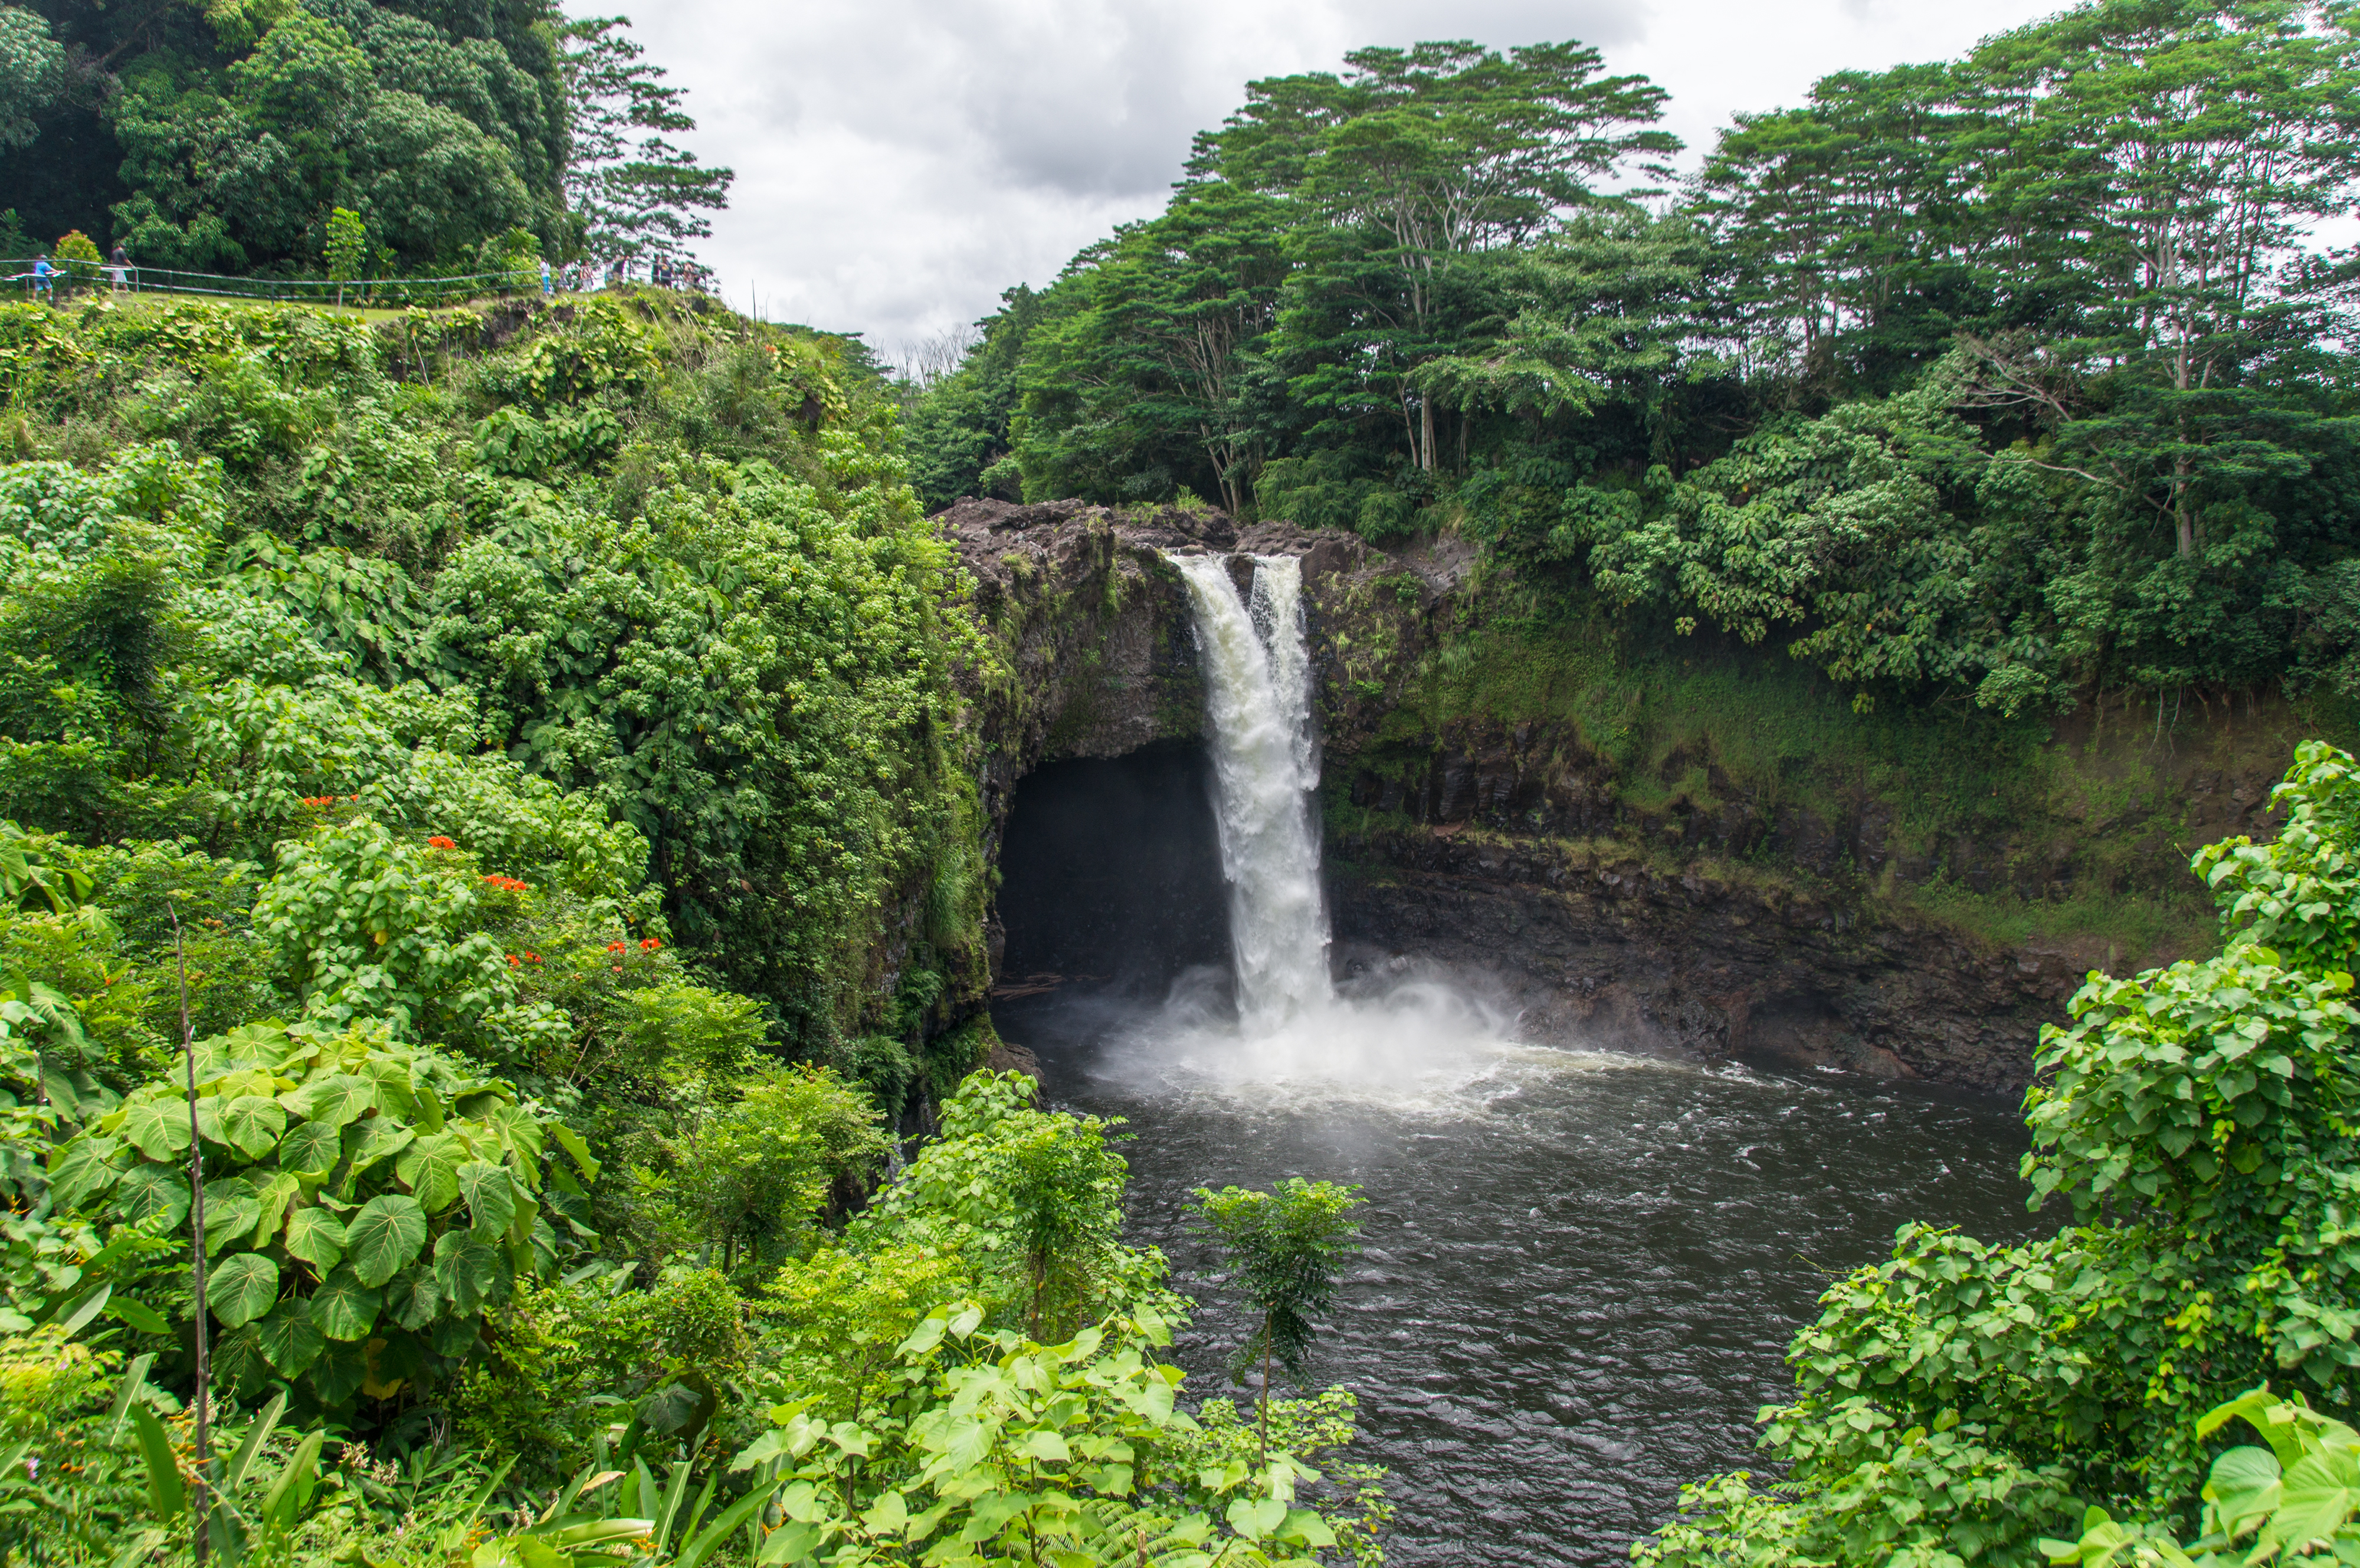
[0,0,732,278]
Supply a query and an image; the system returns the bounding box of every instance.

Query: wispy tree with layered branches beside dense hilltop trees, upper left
[564,17,736,262]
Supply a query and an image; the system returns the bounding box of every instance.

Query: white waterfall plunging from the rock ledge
[1171,555,1333,1034]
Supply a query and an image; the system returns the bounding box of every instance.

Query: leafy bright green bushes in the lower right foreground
[1638,742,2360,1563]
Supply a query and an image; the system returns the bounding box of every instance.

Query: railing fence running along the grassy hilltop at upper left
[0,257,713,309]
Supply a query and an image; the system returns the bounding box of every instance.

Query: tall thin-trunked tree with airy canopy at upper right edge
[1964,0,2360,560]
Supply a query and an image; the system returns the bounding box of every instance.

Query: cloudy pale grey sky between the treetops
[604,0,2060,356]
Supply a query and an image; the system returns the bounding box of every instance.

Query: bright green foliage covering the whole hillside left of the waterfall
[0,290,1385,1568]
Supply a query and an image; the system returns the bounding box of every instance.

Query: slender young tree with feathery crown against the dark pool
[1192,1176,1364,1462]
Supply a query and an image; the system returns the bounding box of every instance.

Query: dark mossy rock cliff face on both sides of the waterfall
[942,501,2284,1091]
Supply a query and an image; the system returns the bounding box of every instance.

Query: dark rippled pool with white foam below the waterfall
[994,999,2034,1566]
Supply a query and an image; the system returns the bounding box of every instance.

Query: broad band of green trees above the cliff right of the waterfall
[909,0,2360,713]
